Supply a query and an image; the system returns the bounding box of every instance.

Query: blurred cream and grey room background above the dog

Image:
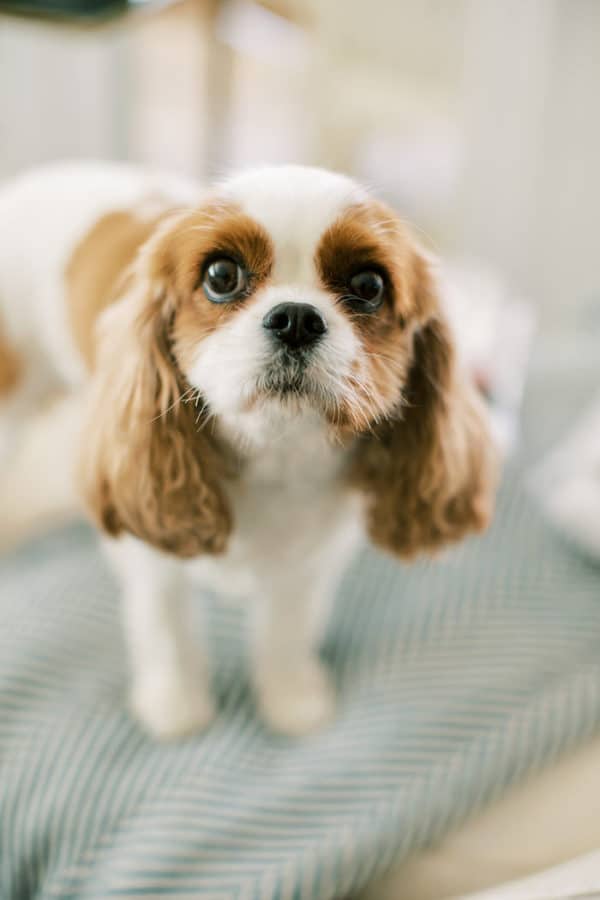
[0,0,600,341]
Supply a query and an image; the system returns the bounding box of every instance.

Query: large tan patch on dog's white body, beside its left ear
[65,210,164,369]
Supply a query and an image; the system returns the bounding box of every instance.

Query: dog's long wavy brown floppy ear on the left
[80,232,231,557]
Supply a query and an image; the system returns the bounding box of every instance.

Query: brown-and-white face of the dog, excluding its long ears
[148,167,434,440]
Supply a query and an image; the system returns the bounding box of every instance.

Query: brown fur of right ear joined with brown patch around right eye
[317,204,495,558]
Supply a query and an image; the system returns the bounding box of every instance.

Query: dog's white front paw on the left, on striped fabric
[130,671,215,741]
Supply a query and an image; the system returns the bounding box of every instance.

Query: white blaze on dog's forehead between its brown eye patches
[220,166,368,282]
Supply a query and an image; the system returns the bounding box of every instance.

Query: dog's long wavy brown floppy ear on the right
[355,250,496,558]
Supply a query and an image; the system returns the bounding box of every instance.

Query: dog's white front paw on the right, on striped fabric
[256,659,335,737]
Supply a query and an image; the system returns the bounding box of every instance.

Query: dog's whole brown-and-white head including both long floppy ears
[84,167,492,556]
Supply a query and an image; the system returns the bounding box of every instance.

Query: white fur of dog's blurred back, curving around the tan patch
[0,162,198,385]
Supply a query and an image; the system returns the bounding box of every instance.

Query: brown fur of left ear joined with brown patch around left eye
[81,207,271,557]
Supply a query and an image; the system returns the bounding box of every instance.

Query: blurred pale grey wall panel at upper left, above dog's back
[0,16,129,175]
